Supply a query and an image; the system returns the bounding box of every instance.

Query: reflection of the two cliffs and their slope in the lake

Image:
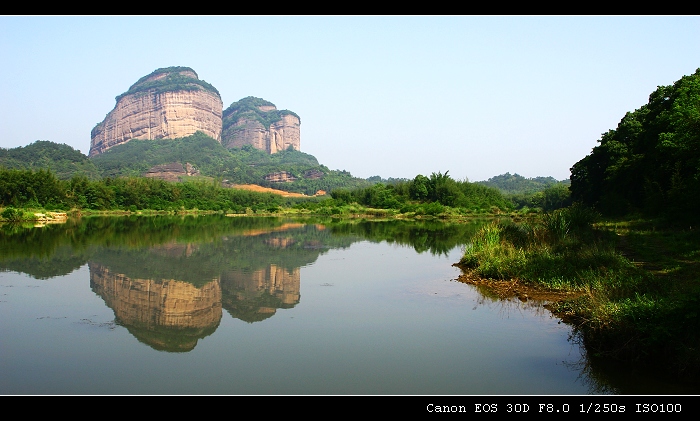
[88,218,332,352]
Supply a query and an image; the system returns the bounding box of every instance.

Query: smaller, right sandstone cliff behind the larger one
[221,96,301,153]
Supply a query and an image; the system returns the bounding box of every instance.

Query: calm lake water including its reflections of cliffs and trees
[0,216,696,395]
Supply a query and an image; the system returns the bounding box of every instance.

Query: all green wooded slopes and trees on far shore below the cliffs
[0,138,556,215]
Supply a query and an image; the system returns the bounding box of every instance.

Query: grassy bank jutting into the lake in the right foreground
[460,208,700,379]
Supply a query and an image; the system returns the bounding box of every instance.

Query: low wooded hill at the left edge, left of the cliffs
[0,140,100,180]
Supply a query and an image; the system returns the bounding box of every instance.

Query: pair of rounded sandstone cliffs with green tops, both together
[89,67,301,157]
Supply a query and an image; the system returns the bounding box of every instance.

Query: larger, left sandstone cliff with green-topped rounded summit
[89,67,223,156]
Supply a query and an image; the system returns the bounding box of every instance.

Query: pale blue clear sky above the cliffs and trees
[0,15,700,181]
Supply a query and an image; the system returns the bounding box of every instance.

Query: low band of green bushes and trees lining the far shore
[0,164,512,220]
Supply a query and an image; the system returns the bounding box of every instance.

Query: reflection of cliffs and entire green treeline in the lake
[0,216,481,352]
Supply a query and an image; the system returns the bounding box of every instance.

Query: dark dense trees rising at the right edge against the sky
[571,69,700,220]
